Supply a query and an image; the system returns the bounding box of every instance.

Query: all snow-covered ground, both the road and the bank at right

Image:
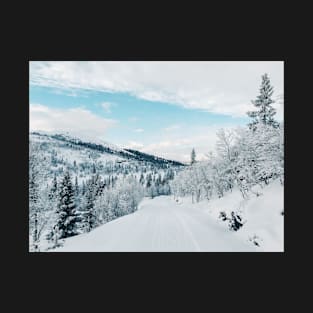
[50,182,284,252]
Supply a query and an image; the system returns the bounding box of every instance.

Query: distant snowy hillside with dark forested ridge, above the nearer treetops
[29,132,184,185]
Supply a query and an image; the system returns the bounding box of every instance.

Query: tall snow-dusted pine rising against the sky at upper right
[247,73,279,131]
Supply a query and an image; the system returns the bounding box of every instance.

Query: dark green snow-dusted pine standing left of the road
[56,172,79,239]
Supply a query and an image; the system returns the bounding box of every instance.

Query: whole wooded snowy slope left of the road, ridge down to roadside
[29,132,183,249]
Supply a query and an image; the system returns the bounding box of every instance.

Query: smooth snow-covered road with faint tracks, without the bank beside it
[53,196,255,252]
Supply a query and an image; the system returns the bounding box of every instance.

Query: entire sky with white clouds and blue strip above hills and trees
[29,61,284,162]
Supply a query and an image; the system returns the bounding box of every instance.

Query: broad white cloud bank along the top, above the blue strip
[30,61,284,116]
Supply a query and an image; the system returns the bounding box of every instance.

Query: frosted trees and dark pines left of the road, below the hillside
[29,142,175,251]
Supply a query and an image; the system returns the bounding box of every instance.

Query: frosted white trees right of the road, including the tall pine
[171,74,284,202]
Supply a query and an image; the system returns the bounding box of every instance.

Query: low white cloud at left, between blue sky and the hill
[29,104,117,139]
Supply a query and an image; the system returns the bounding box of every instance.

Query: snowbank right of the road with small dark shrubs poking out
[194,180,284,252]
